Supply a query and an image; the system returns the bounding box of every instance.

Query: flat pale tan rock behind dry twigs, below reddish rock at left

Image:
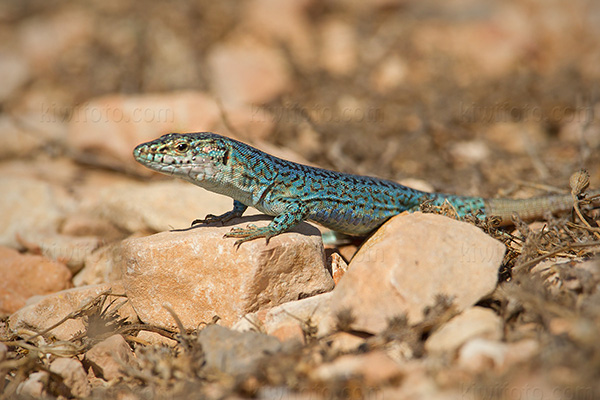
[8,282,138,340]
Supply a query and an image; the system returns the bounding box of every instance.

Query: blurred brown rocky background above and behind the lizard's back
[0,0,600,196]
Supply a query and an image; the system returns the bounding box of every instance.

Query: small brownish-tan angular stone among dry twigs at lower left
[84,335,135,381]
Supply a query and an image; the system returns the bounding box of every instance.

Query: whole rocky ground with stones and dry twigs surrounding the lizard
[0,0,600,399]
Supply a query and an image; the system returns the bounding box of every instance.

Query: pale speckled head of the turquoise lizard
[133,132,230,183]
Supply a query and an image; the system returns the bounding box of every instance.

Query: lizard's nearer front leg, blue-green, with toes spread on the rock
[225,200,308,247]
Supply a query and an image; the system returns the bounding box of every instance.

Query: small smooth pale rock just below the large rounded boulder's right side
[425,307,502,353]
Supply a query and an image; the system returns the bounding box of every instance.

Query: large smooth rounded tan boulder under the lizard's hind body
[331,212,505,332]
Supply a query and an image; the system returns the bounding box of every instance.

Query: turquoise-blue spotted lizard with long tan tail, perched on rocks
[133,132,596,246]
